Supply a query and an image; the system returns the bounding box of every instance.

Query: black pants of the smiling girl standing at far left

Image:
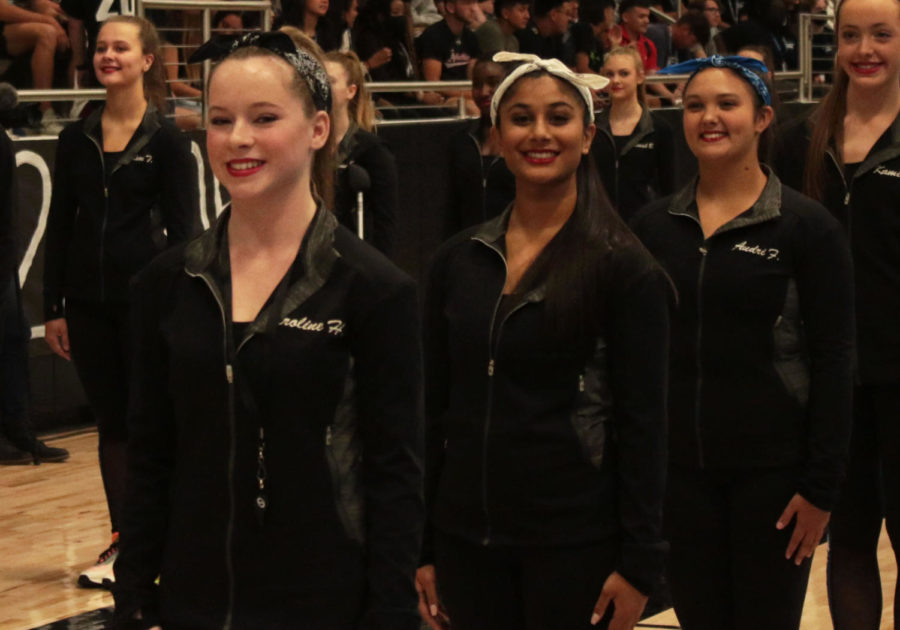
[66,300,130,532]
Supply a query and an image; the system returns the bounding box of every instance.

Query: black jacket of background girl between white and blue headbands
[591,107,675,221]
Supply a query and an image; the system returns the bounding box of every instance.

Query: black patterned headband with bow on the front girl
[188,31,331,112]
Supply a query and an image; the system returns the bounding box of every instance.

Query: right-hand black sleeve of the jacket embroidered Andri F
[796,208,854,510]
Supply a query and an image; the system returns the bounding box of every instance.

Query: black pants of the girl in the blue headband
[664,467,811,630]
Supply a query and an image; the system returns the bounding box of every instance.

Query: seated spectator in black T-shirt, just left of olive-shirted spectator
[418,0,479,114]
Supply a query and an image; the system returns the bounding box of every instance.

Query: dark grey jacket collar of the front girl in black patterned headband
[184,202,340,334]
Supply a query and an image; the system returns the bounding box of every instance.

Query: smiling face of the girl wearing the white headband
[492,75,594,184]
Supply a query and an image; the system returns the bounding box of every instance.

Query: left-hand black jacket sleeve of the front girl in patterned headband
[113,260,176,628]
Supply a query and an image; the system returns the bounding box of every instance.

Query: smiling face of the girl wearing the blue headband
[684,68,774,164]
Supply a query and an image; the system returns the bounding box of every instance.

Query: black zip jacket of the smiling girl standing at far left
[44,105,199,320]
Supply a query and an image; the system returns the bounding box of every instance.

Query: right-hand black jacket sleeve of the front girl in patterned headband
[353,278,424,630]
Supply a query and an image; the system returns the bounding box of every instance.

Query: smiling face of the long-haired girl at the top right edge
[837,0,900,89]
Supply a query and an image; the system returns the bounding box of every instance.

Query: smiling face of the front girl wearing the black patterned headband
[206,56,329,206]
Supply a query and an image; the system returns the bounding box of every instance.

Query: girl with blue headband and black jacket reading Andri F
[632,56,853,630]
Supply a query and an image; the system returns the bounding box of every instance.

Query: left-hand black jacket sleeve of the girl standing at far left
[44,129,78,320]
